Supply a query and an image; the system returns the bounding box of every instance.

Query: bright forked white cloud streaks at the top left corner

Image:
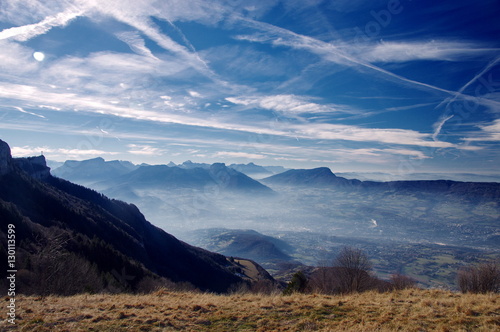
[0,0,221,81]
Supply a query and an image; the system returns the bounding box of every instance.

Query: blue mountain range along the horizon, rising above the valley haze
[52,158,500,198]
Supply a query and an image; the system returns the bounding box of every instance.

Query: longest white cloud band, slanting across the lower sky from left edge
[0,80,456,148]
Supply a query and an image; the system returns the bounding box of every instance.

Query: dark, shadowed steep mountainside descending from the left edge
[0,141,268,294]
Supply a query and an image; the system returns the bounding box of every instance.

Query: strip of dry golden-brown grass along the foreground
[0,290,500,332]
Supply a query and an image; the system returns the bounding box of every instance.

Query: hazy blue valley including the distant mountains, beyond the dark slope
[52,159,500,287]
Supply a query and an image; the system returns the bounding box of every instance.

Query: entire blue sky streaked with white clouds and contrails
[0,0,500,174]
